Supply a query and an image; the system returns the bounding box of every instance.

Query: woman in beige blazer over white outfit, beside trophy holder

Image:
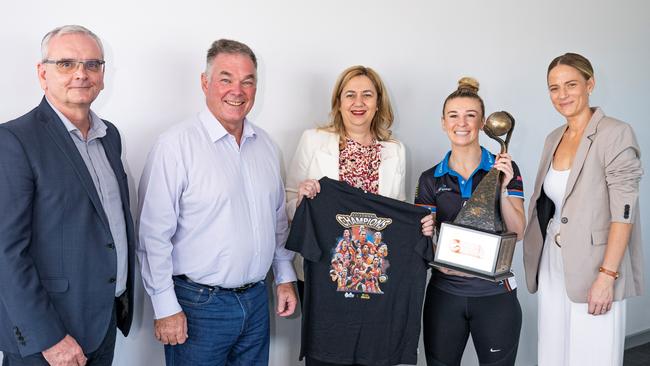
[524,53,643,366]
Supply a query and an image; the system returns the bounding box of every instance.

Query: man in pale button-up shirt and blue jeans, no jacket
[138,39,297,365]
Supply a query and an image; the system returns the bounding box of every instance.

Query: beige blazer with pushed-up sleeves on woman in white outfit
[524,108,644,303]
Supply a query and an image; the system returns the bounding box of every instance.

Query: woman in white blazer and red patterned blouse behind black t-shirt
[286,66,433,366]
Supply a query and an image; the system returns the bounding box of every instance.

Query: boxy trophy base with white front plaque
[432,223,517,282]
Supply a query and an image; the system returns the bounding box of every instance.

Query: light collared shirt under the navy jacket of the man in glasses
[46,98,128,297]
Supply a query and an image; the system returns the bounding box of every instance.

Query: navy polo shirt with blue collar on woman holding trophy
[415,147,524,297]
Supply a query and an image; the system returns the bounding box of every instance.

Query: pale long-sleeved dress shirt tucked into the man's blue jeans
[138,108,296,319]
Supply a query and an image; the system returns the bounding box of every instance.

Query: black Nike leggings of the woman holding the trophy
[422,283,521,366]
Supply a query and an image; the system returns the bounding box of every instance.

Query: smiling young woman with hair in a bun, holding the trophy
[415,78,525,365]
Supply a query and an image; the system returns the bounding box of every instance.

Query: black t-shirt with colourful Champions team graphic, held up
[286,178,433,366]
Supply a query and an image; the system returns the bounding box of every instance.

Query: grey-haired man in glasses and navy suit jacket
[0,26,134,366]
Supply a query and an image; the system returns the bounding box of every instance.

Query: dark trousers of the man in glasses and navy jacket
[2,306,117,366]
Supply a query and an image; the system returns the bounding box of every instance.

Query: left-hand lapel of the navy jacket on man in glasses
[39,97,110,232]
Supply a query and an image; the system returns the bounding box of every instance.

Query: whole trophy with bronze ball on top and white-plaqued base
[433,111,517,282]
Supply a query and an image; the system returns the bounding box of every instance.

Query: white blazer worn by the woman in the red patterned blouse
[285,129,406,280]
